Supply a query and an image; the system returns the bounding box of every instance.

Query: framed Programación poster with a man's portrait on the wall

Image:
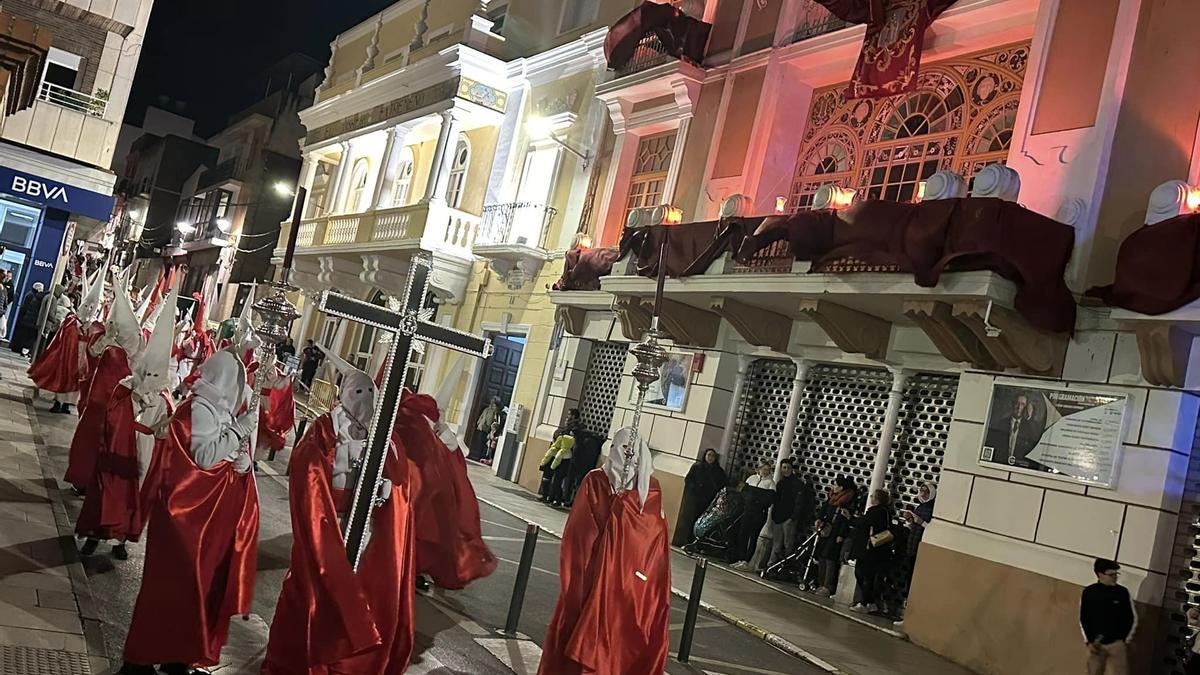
[979,380,1129,488]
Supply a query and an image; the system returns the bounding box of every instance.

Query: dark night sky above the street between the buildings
[125,0,395,136]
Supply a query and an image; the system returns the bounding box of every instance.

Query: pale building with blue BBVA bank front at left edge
[0,0,154,329]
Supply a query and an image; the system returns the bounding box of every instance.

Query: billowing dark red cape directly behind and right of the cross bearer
[395,389,498,590]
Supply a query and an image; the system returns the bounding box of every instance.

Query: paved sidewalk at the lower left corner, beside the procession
[0,350,109,675]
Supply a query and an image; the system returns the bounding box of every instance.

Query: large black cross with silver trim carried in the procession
[320,256,492,569]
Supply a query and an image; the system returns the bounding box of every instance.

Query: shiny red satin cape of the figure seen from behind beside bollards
[538,468,671,675]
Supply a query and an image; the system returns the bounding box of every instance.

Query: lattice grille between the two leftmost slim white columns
[725,359,796,482]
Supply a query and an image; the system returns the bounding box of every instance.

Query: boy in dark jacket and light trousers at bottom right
[1079,557,1138,675]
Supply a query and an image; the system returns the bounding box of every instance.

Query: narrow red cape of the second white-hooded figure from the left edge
[65,345,131,490]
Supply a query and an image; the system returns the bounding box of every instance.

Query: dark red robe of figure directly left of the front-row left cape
[76,384,142,542]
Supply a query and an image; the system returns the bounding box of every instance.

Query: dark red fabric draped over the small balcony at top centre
[604,2,713,70]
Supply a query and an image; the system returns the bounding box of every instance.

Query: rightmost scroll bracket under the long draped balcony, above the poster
[953,300,1068,375]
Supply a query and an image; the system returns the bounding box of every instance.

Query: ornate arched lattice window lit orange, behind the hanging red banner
[791,44,1028,209]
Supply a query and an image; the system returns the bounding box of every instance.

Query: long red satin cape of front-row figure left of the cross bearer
[125,399,258,665]
